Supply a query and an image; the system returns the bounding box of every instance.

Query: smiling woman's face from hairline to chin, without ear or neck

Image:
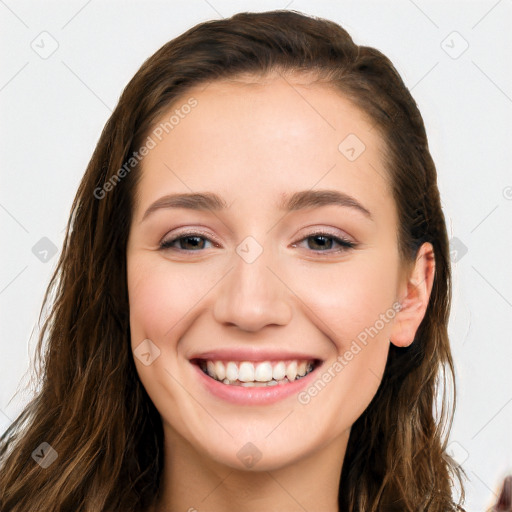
[127,78,412,470]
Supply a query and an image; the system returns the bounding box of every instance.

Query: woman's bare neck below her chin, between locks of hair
[152,424,350,512]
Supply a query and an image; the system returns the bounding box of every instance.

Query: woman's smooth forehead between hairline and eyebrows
[132,76,391,221]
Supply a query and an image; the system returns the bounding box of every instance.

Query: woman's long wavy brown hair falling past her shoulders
[0,11,464,512]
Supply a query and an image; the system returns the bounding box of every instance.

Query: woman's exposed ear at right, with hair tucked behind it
[390,242,435,347]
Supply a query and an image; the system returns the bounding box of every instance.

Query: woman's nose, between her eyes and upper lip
[213,240,292,331]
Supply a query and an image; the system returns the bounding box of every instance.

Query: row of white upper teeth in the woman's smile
[201,360,313,382]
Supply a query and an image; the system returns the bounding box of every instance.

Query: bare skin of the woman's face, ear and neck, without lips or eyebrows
[127,76,434,512]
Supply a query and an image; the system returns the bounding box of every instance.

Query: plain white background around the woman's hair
[0,0,512,512]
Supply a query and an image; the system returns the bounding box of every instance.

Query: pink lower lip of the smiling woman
[192,363,320,405]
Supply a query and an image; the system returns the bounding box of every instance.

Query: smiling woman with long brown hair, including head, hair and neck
[0,11,464,512]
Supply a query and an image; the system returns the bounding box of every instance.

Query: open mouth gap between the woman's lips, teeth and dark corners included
[191,359,321,387]
